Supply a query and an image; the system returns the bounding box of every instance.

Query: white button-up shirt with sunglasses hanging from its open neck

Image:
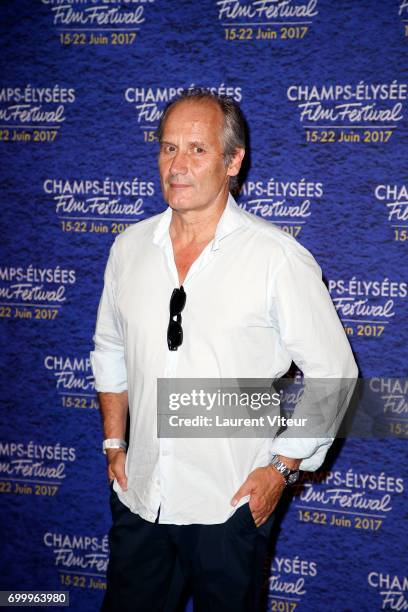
[91,196,357,525]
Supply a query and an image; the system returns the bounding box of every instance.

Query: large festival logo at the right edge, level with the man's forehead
[286,80,408,144]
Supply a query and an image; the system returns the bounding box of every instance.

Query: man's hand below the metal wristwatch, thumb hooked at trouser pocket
[231,465,286,527]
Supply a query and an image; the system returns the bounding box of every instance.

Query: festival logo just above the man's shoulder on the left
[43,177,155,234]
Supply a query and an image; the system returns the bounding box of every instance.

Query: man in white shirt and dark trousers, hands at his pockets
[91,91,357,612]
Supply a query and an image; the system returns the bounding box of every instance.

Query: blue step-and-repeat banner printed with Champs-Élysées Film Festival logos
[0,0,408,612]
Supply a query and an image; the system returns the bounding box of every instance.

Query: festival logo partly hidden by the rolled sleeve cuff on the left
[44,355,98,409]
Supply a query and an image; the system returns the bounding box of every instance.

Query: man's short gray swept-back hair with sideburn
[157,87,247,193]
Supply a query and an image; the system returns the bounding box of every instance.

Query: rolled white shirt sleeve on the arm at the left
[90,244,127,393]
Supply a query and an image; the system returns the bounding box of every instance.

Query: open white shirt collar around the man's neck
[153,194,248,251]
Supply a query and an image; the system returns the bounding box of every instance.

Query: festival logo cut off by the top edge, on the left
[41,0,155,47]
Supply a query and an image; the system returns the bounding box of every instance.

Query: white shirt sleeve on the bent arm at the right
[270,245,358,471]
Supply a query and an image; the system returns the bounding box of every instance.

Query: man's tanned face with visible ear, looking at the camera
[159,100,240,211]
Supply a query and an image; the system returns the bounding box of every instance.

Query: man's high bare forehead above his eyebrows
[163,100,224,139]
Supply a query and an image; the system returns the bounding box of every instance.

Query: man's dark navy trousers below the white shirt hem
[101,490,273,612]
